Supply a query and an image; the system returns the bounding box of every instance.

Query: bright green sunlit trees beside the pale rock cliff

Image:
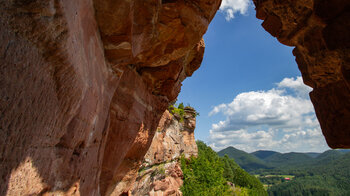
[181,141,267,196]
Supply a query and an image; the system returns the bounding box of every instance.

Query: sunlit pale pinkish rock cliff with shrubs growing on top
[129,108,198,196]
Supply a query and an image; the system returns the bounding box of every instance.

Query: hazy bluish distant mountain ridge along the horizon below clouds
[218,146,350,172]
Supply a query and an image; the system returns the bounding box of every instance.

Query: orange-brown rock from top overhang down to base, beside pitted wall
[94,0,220,195]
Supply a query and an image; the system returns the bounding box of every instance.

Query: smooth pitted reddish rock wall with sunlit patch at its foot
[0,0,120,195]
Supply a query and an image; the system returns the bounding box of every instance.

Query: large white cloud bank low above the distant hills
[209,77,328,152]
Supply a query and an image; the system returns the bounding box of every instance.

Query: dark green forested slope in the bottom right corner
[268,152,350,196]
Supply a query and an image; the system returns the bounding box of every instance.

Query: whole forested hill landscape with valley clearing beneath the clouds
[218,147,350,196]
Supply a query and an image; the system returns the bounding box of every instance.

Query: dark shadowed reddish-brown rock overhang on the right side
[254,0,350,148]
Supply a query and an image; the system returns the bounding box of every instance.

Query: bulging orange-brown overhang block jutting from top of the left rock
[94,0,221,101]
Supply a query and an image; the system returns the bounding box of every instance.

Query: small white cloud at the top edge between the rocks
[220,0,250,21]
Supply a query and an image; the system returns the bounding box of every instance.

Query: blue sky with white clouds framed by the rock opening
[178,0,329,152]
